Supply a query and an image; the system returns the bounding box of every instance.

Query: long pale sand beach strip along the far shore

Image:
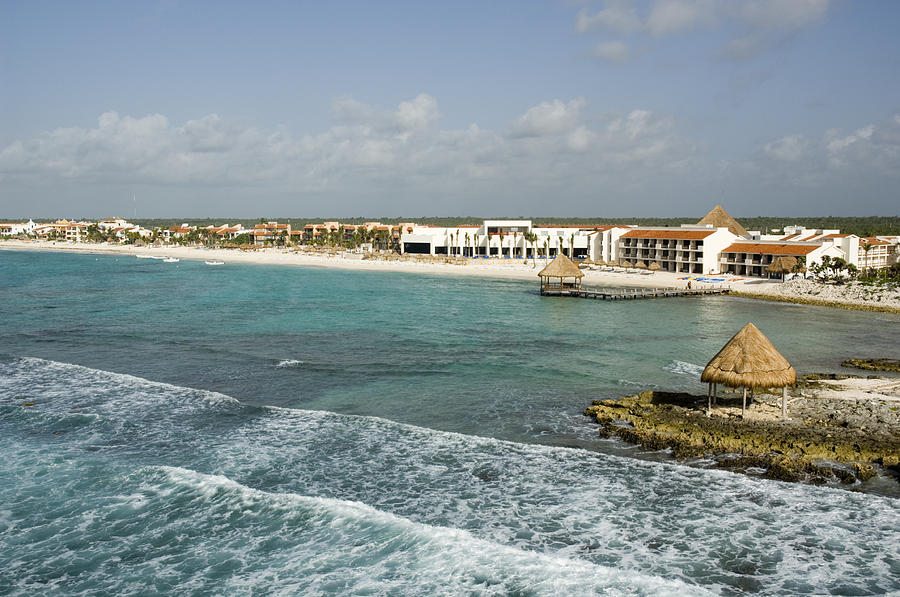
[0,240,900,314]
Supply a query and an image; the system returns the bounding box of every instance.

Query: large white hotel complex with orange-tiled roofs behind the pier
[400,206,900,277]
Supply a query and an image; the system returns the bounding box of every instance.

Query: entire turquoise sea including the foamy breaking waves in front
[0,251,900,595]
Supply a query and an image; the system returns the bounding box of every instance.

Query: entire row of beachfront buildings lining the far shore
[0,205,900,277]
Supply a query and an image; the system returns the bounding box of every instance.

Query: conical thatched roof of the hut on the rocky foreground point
[700,323,797,388]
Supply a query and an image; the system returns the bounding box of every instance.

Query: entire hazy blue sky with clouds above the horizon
[0,0,900,219]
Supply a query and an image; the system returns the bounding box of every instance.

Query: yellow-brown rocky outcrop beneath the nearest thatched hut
[584,376,900,485]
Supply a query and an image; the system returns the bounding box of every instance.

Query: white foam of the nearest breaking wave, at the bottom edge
[144,467,708,595]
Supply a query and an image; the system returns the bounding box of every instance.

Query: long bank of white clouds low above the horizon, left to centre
[0,94,694,203]
